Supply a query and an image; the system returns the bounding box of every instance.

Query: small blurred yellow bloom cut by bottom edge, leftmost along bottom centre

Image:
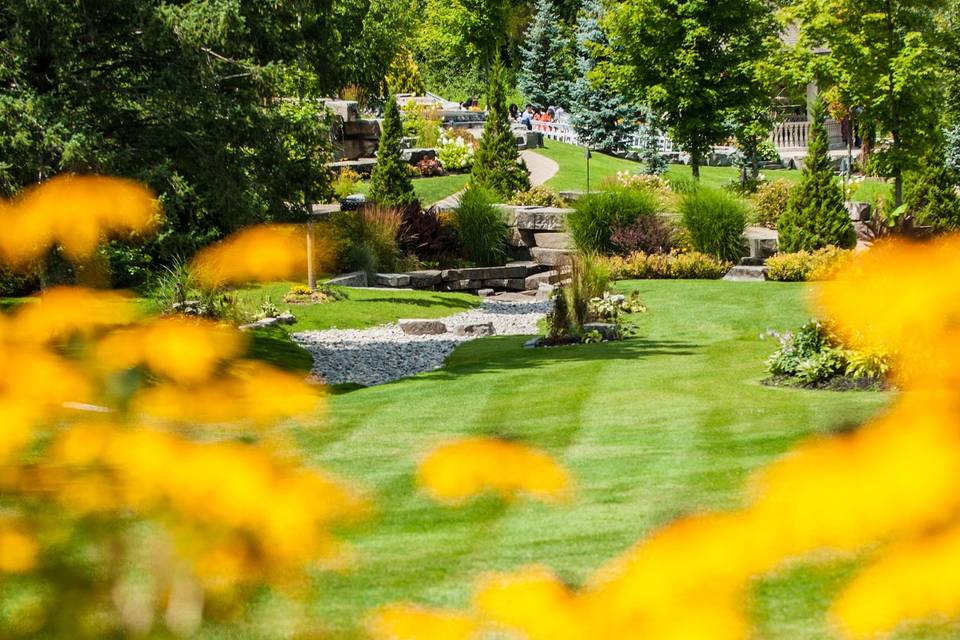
[367,604,475,640]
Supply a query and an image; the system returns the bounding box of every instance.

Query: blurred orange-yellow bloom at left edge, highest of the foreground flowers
[0,174,160,267]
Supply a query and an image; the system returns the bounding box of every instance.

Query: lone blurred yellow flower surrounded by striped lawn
[417,438,571,504]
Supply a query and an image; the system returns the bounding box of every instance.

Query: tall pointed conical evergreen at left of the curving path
[471,58,530,202]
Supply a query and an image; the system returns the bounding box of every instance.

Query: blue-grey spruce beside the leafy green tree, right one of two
[571,0,641,152]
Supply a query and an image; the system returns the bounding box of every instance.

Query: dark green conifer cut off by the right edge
[904,146,960,231]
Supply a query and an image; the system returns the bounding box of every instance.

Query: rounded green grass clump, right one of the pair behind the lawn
[680,189,749,262]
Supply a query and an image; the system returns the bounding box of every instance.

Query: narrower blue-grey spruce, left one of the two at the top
[517,0,570,108]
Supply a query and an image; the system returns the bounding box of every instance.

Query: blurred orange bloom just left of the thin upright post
[192,225,307,288]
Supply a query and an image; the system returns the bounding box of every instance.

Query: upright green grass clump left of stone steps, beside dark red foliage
[453,185,510,266]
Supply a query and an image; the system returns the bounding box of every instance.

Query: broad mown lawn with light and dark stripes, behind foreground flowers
[249,281,900,640]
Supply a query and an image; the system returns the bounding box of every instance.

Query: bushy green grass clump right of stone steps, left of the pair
[567,187,659,254]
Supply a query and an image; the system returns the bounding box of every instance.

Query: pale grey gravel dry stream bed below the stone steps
[292,300,553,385]
